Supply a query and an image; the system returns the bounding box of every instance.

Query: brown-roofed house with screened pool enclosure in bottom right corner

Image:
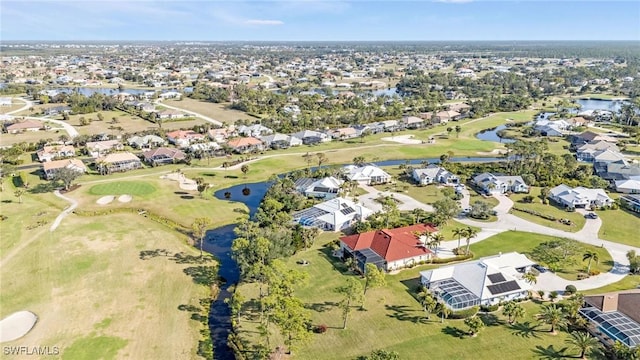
[578,289,640,349]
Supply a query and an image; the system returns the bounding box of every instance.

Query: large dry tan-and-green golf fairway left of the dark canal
[0,214,209,360]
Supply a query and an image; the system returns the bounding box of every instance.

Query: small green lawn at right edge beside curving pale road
[598,210,640,247]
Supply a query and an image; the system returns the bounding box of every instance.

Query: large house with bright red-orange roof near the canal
[340,224,438,271]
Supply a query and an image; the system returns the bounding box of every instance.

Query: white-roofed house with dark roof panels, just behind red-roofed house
[293,197,373,231]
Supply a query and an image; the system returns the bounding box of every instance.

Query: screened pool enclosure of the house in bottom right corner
[580,307,640,347]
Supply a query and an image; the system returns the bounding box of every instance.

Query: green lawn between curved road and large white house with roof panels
[471,231,613,280]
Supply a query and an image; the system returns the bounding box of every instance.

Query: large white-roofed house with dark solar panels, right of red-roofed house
[420,252,535,310]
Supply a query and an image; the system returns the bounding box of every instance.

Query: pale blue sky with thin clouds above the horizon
[0,0,640,41]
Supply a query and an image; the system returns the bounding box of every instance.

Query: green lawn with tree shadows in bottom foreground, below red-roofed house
[239,235,580,359]
